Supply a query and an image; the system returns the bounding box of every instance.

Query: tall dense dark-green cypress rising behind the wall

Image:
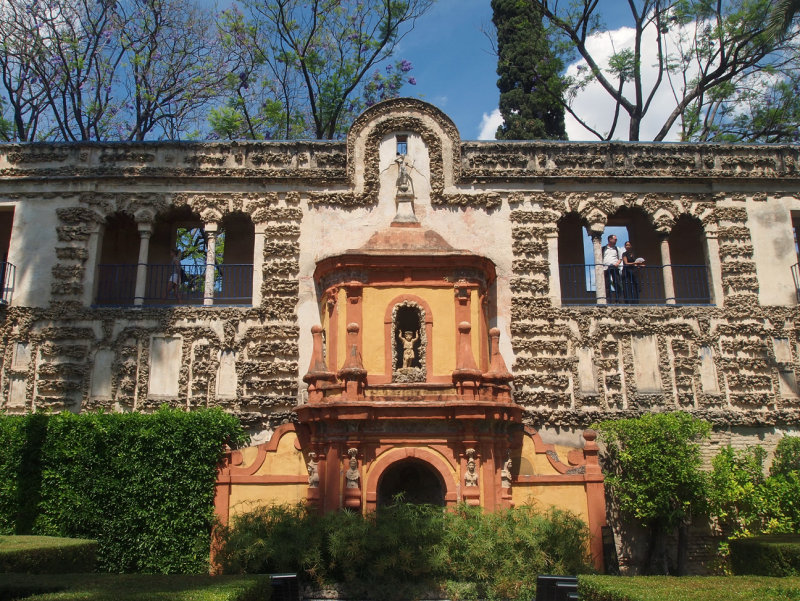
[492,0,567,140]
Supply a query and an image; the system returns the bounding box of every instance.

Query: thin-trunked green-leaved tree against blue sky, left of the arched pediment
[217,0,433,139]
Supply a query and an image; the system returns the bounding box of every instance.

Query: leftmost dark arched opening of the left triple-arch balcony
[94,213,139,305]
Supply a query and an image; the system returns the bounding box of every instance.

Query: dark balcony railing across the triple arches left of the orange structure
[95,264,253,306]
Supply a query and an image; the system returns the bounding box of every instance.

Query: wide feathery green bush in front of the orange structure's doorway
[217,502,590,599]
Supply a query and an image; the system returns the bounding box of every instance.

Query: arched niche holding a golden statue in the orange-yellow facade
[392,300,428,382]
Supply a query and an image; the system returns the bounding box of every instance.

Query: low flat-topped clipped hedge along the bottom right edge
[578,576,800,601]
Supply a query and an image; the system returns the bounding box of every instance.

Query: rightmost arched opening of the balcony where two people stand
[669,215,711,305]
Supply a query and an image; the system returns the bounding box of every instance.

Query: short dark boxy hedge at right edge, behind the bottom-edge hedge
[729,534,800,576]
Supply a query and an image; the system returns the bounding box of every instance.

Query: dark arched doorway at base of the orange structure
[378,459,444,507]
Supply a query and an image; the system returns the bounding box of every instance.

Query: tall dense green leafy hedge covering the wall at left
[0,408,243,573]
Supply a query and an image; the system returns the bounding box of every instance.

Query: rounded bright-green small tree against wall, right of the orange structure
[599,412,711,574]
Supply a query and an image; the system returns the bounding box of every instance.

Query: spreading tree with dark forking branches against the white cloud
[532,0,800,142]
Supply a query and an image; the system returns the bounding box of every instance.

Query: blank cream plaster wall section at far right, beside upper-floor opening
[747,198,800,306]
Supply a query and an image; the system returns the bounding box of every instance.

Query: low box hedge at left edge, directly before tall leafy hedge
[0,536,97,574]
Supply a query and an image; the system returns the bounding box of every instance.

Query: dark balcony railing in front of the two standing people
[559,264,711,305]
